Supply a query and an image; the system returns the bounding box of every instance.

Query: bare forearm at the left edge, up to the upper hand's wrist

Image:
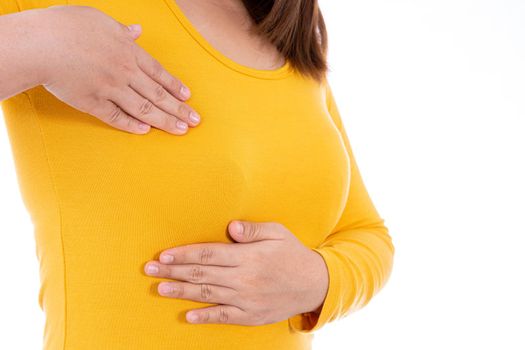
[0,9,50,101]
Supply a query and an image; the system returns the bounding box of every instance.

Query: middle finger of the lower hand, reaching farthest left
[145,261,237,288]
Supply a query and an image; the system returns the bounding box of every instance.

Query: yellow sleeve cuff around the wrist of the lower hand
[288,248,341,334]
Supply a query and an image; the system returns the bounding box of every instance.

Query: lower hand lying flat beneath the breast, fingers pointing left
[145,221,328,325]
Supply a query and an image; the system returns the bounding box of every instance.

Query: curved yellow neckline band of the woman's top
[164,0,293,79]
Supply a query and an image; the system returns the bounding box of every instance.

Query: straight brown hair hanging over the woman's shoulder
[243,0,328,81]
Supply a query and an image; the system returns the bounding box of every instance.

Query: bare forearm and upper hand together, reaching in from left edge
[0,6,198,135]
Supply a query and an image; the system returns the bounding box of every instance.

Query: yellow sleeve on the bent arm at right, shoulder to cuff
[289,83,394,333]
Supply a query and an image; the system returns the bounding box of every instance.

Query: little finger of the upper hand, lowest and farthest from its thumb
[89,100,150,134]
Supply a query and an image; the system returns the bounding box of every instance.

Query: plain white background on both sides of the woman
[0,0,525,350]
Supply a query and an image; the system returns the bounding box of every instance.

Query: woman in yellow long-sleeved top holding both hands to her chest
[0,0,394,350]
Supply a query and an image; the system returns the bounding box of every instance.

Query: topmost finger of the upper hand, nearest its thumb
[135,45,191,101]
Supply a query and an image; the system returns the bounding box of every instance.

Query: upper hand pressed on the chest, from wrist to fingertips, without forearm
[34,5,198,135]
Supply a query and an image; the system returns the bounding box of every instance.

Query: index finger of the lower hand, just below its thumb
[159,243,244,266]
